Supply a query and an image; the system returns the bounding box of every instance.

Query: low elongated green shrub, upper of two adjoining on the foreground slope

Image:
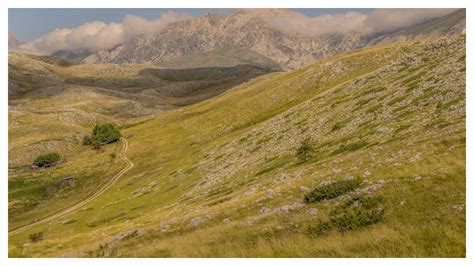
[304,179,360,203]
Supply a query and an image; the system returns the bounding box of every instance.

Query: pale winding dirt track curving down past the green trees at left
[8,138,133,236]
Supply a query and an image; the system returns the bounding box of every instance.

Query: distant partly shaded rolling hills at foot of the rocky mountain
[8,48,281,106]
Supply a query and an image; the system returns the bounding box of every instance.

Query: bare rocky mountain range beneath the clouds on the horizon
[80,9,465,69]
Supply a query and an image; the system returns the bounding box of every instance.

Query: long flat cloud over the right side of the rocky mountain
[267,8,454,36]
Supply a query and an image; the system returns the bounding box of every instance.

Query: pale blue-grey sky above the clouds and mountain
[8,8,371,42]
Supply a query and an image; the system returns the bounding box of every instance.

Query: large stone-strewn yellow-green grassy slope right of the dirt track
[9,36,466,257]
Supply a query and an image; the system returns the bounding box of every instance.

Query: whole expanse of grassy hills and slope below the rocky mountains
[8,35,466,257]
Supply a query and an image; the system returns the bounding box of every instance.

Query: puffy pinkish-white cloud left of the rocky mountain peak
[16,11,192,54]
